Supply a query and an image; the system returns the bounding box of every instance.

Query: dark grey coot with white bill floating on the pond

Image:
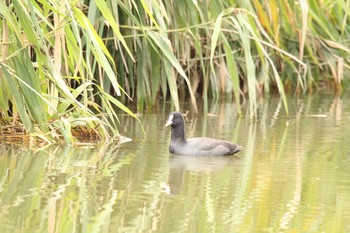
[165,112,243,156]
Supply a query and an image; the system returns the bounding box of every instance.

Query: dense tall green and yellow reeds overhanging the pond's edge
[0,0,350,142]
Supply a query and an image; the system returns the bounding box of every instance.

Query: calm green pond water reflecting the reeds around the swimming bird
[0,94,350,233]
